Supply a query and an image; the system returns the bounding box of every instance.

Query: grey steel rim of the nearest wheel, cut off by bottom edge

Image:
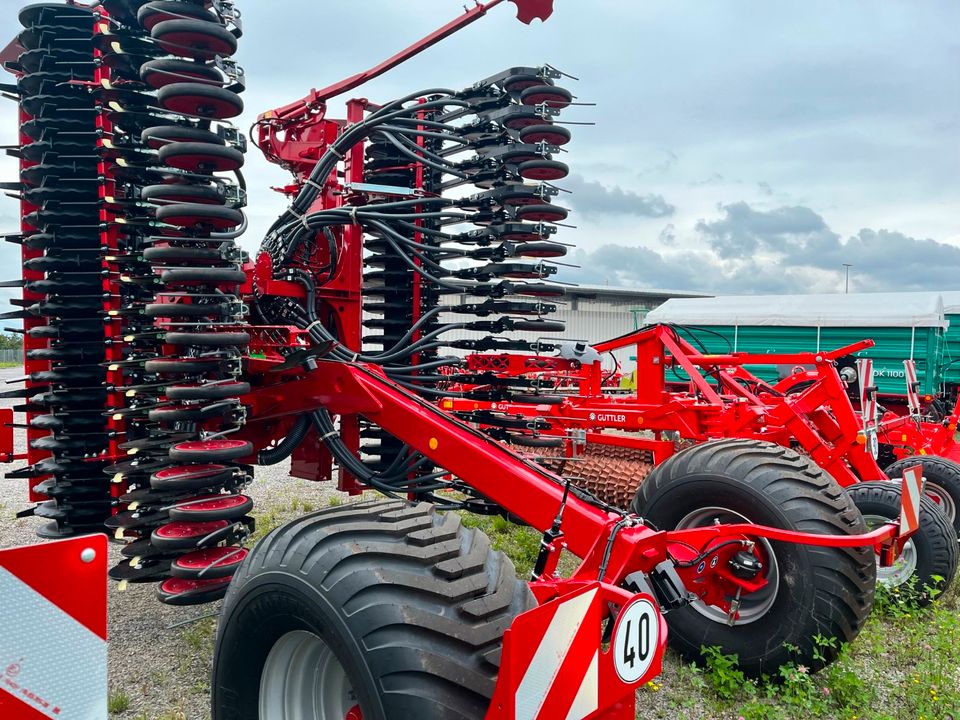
[260,630,357,720]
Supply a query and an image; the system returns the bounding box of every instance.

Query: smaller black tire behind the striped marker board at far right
[847,480,960,605]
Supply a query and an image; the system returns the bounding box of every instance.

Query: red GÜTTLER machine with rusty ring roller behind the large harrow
[440,325,960,596]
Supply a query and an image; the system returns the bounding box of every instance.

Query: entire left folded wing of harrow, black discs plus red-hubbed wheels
[2,0,253,604]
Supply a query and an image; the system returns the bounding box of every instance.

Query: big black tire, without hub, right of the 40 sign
[631,440,876,677]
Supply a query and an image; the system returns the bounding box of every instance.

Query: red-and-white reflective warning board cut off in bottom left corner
[0,535,107,720]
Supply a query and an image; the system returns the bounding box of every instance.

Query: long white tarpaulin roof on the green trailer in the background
[644,292,948,327]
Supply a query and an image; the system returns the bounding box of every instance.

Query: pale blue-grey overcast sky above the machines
[0,0,960,293]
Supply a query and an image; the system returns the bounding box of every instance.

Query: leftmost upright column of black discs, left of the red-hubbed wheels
[4,4,111,538]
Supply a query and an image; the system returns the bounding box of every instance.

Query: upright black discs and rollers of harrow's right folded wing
[363,67,572,469]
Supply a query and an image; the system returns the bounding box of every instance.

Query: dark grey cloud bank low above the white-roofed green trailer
[561,202,960,294]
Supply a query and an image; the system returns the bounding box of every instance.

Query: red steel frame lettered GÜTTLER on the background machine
[441,325,886,486]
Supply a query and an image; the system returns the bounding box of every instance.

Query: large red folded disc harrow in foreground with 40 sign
[3,0,940,720]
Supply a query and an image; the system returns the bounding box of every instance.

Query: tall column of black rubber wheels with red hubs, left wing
[98,0,253,604]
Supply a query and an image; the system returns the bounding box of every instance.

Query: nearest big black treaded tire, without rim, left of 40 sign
[212,501,535,720]
